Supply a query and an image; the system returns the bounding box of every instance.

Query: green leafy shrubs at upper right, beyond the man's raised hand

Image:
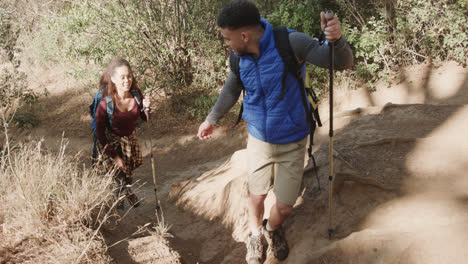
[338,0,468,87]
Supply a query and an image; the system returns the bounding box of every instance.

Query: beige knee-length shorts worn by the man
[247,134,307,206]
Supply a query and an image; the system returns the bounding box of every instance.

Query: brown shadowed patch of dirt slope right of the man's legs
[285,64,468,263]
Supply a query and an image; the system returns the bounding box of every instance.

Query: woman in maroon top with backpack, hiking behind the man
[96,58,151,209]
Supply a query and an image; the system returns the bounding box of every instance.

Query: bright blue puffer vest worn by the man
[239,18,309,144]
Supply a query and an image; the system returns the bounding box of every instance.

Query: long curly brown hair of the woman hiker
[99,58,141,97]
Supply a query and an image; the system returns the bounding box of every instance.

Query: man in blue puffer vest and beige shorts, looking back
[198,0,353,264]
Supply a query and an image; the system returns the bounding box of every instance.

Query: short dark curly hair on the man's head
[218,0,260,29]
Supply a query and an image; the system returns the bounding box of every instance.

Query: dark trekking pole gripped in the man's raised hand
[325,11,335,239]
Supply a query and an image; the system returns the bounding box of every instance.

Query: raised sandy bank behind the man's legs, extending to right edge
[166,64,468,264]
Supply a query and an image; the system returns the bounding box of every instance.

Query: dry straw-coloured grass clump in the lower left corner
[0,109,115,263]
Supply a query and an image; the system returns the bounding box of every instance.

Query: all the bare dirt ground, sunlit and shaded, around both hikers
[21,60,468,264]
